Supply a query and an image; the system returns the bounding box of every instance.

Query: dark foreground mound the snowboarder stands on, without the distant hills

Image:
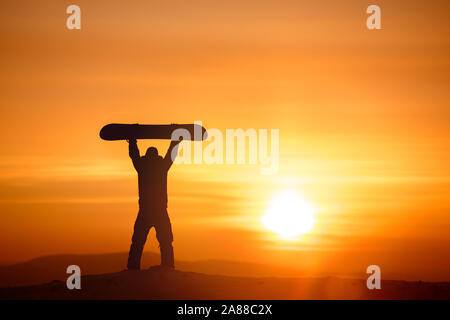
[0,266,450,300]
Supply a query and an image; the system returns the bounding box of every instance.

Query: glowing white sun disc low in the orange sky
[261,190,315,240]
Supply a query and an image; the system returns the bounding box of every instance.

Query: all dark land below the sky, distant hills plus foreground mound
[0,252,450,299]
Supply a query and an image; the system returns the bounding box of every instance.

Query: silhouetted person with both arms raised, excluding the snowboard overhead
[127,139,182,270]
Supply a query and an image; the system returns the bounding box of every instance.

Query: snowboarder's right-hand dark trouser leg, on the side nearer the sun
[155,210,175,268]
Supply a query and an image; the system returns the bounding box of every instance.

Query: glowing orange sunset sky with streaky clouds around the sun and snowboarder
[0,0,450,281]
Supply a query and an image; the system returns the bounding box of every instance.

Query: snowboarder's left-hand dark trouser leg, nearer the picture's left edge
[127,211,151,270]
